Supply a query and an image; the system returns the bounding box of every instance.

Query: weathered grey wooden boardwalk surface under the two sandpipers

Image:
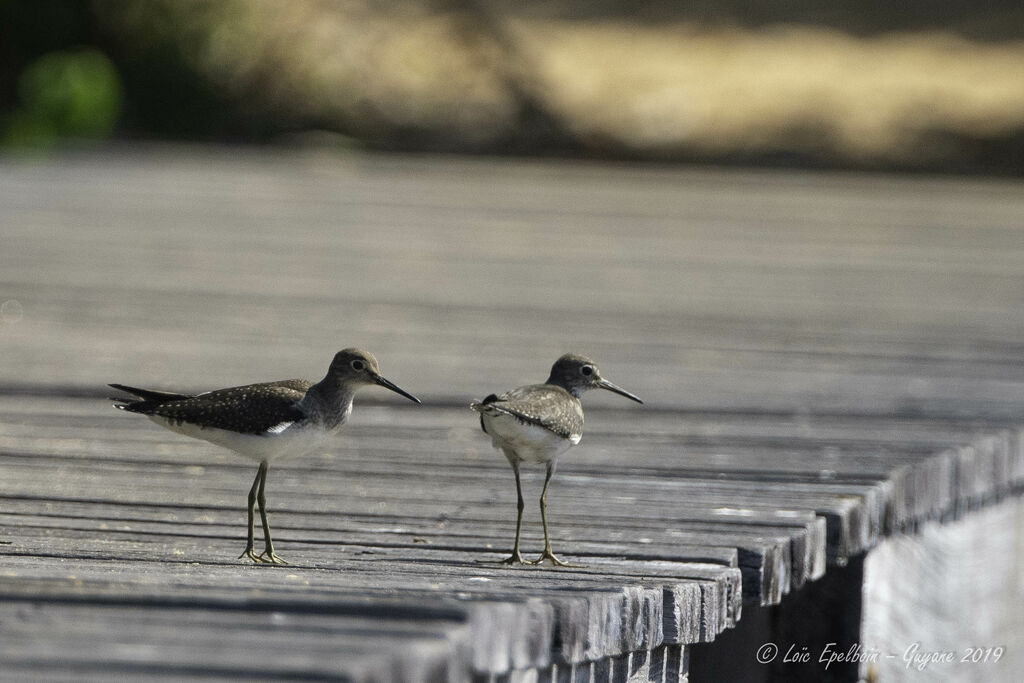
[0,150,1024,681]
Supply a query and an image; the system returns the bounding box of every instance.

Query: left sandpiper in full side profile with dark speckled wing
[110,348,420,564]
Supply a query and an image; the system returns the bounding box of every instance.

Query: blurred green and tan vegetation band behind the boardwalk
[0,0,1024,174]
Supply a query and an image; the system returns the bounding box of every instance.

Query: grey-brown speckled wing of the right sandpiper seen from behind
[470,384,583,440]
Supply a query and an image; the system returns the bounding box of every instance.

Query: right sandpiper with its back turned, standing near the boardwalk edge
[470,353,643,566]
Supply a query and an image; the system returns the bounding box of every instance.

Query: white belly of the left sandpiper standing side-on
[146,415,334,462]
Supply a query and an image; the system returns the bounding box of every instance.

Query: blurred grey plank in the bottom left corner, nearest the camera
[0,602,468,682]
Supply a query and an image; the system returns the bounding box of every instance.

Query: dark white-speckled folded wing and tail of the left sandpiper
[112,380,312,435]
